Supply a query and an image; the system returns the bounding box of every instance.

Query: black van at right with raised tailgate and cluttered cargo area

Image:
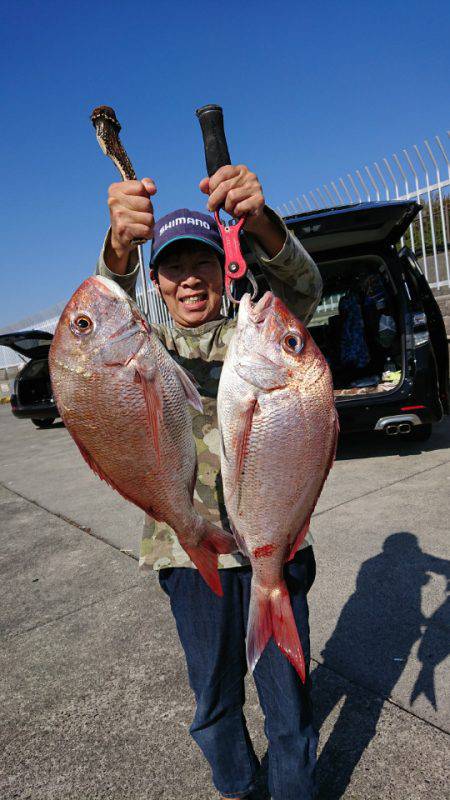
[285,200,449,440]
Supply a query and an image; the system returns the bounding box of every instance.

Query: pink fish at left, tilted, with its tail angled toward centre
[49,277,236,594]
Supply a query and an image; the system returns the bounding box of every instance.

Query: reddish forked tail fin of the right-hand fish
[247,581,306,683]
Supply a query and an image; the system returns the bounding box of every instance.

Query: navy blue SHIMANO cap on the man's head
[150,208,223,264]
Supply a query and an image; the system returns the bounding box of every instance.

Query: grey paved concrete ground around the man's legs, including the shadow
[0,407,450,800]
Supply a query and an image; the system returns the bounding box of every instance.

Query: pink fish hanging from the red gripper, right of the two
[218,292,338,681]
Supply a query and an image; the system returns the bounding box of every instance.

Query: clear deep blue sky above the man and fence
[0,0,450,327]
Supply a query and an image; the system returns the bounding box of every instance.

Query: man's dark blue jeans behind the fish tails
[159,547,317,800]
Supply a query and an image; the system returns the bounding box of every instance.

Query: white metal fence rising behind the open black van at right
[277,131,450,291]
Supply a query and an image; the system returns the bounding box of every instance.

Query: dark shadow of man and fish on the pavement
[313,532,450,800]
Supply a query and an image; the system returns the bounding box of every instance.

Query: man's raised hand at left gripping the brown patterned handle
[105,178,156,275]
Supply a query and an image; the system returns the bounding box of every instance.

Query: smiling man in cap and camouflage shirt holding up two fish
[97,165,322,800]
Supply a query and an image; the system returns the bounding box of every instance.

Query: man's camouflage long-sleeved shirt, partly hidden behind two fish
[97,209,322,570]
